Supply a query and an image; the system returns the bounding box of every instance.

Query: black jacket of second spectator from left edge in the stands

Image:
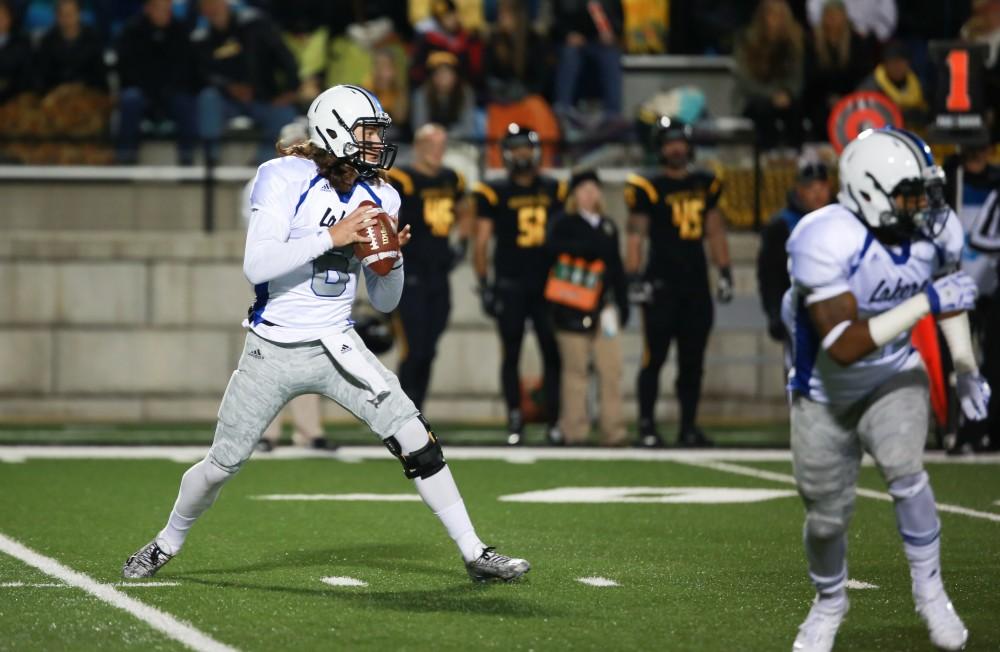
[34,25,108,93]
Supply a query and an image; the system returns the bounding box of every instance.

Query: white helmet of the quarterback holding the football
[307,84,396,177]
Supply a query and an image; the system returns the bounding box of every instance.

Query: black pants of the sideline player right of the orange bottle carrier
[638,290,714,431]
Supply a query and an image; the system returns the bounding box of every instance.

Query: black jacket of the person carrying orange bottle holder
[546,214,629,333]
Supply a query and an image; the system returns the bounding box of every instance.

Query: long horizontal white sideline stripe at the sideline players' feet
[0,444,1000,465]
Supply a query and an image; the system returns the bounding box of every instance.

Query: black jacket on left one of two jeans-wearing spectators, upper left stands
[115,14,197,101]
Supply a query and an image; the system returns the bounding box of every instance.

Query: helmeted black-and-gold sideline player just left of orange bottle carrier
[473,124,566,445]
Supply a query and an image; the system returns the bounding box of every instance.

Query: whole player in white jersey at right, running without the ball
[783,128,990,651]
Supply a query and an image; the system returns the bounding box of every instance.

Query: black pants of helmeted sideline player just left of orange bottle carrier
[497,279,560,425]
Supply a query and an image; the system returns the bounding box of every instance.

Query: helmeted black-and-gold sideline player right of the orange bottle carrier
[625,117,733,447]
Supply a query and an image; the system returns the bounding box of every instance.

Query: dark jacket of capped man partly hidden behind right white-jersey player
[757,190,806,340]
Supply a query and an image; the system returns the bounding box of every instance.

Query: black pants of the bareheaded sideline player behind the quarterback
[396,271,451,410]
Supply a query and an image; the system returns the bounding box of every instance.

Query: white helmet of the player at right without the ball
[837,127,949,238]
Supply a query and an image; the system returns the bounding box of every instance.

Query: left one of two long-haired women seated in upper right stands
[735,0,805,149]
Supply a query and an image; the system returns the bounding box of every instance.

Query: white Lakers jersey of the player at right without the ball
[782,204,963,404]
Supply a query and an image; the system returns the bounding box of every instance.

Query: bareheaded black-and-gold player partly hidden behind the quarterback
[388,124,469,410]
